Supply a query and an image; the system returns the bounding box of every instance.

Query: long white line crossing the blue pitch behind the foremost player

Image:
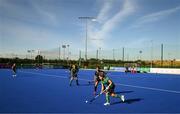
[21,71,180,94]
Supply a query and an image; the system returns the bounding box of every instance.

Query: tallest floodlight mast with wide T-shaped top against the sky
[79,17,96,61]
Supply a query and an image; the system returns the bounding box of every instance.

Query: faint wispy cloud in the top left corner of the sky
[0,0,59,26]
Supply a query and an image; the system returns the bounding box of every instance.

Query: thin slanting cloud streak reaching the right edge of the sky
[132,6,180,28]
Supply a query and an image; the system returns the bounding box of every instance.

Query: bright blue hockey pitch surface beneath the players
[0,69,180,113]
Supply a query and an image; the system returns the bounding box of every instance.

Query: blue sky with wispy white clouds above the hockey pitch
[0,0,180,59]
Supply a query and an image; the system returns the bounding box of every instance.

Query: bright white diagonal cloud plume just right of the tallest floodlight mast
[90,0,135,47]
